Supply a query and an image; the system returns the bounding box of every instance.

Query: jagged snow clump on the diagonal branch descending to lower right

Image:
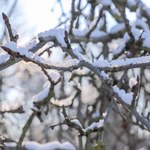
[113,86,133,105]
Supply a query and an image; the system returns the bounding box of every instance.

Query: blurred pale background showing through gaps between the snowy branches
[0,0,150,150]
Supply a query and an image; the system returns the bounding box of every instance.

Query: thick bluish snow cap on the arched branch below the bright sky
[38,29,67,47]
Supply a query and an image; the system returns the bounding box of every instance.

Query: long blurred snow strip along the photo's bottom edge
[24,141,75,150]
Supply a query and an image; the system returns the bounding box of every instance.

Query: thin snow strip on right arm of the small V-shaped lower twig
[85,119,104,131]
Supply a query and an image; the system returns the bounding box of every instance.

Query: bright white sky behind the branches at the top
[0,0,150,43]
